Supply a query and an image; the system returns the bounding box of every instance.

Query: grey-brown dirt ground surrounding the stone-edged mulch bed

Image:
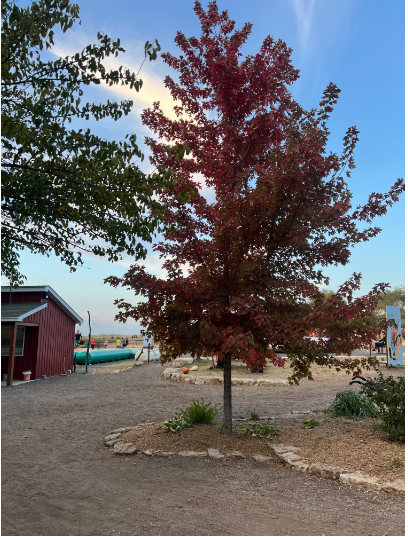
[1,363,404,535]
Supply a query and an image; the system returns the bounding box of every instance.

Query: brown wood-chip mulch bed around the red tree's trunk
[122,413,405,482]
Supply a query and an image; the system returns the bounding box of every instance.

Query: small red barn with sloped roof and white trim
[1,285,83,386]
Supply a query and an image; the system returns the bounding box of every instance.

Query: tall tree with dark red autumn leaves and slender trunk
[107,2,403,434]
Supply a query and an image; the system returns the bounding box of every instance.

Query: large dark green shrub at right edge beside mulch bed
[361,372,405,443]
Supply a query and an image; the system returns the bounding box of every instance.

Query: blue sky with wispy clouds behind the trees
[2,0,405,334]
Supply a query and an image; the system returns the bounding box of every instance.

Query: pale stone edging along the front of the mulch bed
[105,420,405,494]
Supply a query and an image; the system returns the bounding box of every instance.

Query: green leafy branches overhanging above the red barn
[1,0,167,284]
